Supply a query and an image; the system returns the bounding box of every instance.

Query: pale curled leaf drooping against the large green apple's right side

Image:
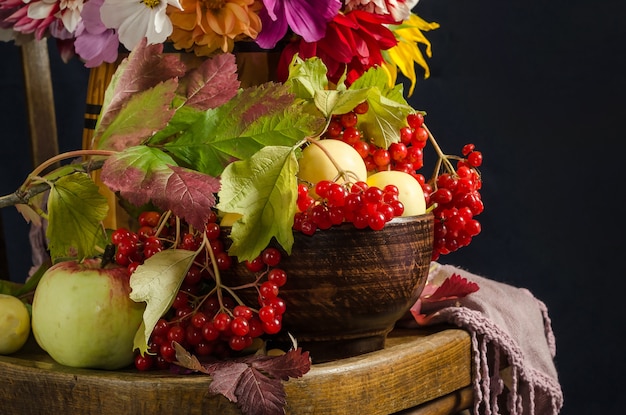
[130,249,196,354]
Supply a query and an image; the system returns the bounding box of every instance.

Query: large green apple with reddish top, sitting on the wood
[32,259,145,369]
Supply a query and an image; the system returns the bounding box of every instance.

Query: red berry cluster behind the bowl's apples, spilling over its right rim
[316,102,484,259]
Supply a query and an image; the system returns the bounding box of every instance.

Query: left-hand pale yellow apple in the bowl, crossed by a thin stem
[298,139,367,185]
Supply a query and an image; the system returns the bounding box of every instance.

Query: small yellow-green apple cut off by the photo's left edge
[0,294,30,354]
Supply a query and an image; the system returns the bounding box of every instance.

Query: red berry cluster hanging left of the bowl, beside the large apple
[111,211,287,370]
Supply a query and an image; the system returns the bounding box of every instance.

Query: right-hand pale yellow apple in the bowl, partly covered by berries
[367,170,426,216]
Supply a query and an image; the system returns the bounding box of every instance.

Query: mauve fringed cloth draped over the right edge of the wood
[411,263,563,415]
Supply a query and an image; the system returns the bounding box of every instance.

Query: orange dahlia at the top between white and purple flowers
[167,0,263,56]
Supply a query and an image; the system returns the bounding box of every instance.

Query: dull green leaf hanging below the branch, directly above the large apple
[46,173,109,262]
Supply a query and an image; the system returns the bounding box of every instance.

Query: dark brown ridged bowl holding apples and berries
[225,214,433,362]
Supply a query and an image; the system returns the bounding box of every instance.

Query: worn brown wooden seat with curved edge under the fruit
[0,329,471,415]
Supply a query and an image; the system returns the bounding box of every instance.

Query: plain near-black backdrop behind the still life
[0,0,626,415]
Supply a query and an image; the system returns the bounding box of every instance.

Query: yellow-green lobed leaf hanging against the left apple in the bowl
[217,146,298,261]
